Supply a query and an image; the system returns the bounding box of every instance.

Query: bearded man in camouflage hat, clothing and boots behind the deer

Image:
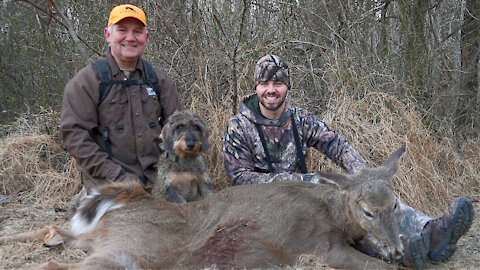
[223,54,473,269]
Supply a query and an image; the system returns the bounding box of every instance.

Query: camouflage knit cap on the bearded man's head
[253,54,290,89]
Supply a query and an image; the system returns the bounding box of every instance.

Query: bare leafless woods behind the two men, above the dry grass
[0,0,480,135]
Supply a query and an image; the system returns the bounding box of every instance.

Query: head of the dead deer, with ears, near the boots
[317,147,405,261]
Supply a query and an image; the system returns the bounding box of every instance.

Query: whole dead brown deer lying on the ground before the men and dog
[0,147,405,269]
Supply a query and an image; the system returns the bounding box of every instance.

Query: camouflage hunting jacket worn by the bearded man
[223,94,366,185]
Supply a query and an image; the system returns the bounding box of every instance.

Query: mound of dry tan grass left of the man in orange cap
[0,111,81,207]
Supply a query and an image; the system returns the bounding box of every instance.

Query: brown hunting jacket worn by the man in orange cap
[60,49,181,191]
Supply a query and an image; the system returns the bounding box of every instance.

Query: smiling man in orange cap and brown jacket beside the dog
[60,4,181,196]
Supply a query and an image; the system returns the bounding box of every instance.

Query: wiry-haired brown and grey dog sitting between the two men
[152,111,213,203]
